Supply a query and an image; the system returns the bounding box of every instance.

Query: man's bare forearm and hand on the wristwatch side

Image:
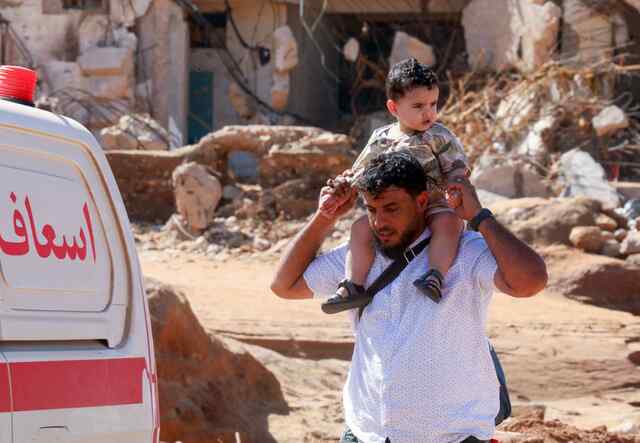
[447,177,548,297]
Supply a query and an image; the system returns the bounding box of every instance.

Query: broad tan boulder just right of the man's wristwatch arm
[489,198,600,245]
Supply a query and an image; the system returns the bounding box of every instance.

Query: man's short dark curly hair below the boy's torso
[355,151,429,197]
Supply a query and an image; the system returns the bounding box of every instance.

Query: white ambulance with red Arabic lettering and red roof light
[0,66,160,443]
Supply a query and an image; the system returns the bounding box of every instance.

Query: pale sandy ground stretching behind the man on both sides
[140,251,640,443]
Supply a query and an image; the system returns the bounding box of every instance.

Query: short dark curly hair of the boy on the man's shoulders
[385,57,438,100]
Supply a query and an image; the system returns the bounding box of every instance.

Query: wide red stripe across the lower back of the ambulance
[6,357,146,412]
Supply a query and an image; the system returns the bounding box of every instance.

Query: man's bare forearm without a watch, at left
[271,212,335,298]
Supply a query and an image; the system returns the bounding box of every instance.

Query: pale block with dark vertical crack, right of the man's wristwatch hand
[471,155,551,198]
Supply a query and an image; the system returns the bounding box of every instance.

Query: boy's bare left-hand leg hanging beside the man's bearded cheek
[337,216,375,297]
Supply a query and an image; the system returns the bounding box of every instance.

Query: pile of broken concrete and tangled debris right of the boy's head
[441,60,640,197]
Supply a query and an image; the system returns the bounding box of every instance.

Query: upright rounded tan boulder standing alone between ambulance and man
[172,162,222,232]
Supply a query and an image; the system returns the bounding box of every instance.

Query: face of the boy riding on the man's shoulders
[387,86,440,131]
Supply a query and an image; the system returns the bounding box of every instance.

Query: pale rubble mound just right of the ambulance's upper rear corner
[100,114,169,151]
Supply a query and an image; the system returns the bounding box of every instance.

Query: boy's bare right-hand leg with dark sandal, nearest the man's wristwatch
[414,212,464,301]
